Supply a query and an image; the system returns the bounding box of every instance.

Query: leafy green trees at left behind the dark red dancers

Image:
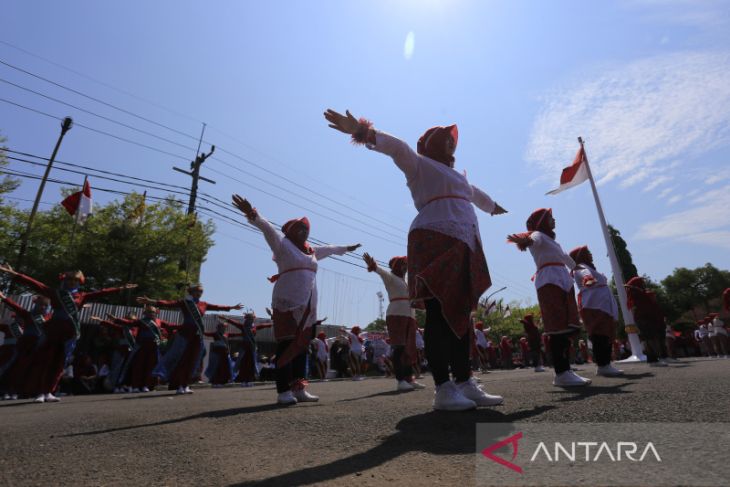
[0,191,214,304]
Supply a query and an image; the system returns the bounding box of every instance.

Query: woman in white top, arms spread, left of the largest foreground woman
[233,195,360,405]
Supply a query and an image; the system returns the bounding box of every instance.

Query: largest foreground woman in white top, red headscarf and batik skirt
[324,110,506,411]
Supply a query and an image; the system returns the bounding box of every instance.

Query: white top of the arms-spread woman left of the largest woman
[251,215,347,328]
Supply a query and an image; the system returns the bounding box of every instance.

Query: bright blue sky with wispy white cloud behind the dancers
[0,0,730,325]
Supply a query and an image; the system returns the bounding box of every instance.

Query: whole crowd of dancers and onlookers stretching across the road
[0,110,730,411]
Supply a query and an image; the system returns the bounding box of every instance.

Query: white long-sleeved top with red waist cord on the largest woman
[367,131,496,250]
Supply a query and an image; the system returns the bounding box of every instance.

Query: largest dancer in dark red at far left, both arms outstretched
[0,267,137,403]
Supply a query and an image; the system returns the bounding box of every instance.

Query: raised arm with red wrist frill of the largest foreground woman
[324,109,419,181]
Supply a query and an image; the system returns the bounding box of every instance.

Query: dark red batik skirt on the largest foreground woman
[408,229,492,338]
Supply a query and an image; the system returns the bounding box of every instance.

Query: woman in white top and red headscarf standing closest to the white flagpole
[570,245,623,377]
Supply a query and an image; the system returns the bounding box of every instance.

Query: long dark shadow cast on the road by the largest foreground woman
[229,406,555,487]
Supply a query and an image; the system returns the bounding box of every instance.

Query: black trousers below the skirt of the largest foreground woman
[423,299,471,386]
